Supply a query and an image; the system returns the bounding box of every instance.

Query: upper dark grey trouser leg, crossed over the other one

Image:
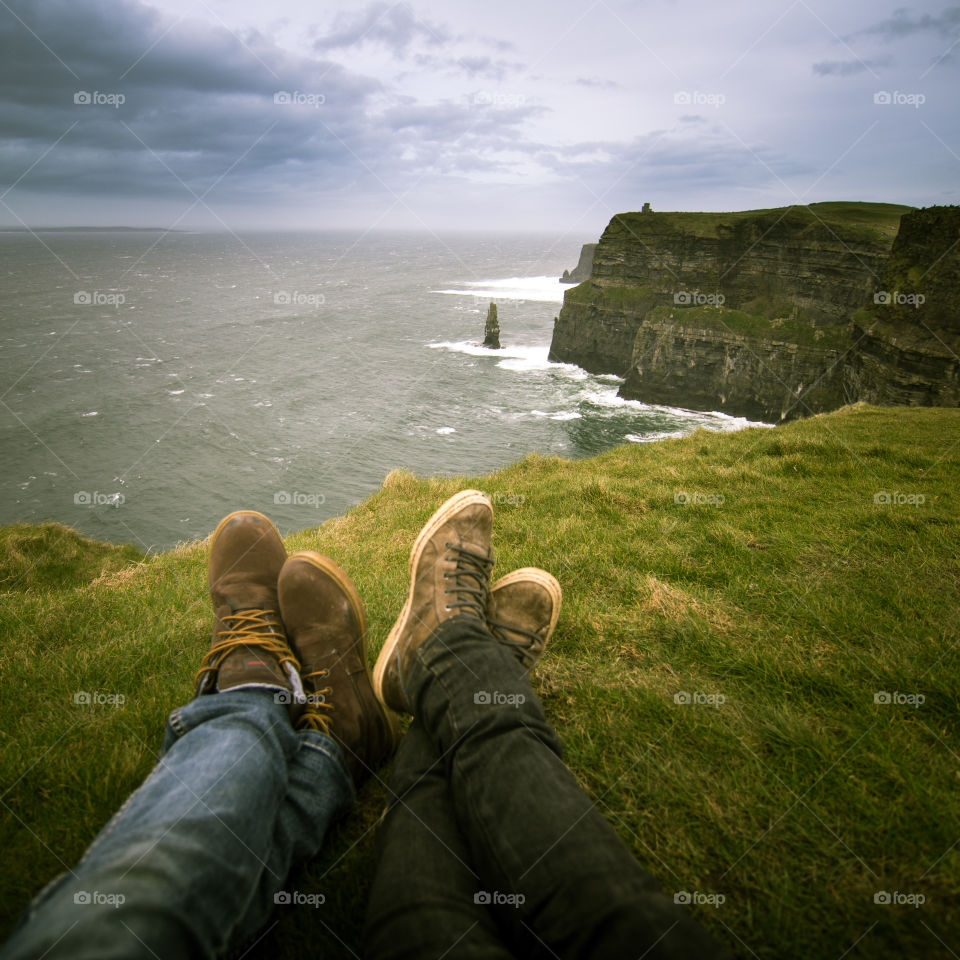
[405,617,719,960]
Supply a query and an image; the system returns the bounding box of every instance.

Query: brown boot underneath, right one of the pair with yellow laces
[277,550,398,786]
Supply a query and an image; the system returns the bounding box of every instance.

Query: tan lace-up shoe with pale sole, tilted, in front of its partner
[373,490,493,713]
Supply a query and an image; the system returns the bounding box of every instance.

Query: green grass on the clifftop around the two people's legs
[0,405,960,960]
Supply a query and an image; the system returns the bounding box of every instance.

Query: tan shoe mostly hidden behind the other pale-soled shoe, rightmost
[487,567,563,673]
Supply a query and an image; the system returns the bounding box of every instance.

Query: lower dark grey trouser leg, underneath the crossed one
[364,720,513,960]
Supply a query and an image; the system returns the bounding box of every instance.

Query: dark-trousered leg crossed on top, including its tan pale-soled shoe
[374,491,718,958]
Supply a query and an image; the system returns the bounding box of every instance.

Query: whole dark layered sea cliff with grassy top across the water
[550,203,960,422]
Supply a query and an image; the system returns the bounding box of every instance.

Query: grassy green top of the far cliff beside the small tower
[608,201,916,240]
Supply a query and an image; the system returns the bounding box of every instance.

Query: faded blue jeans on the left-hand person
[0,689,353,960]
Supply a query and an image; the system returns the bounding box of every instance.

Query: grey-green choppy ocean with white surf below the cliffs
[0,230,764,549]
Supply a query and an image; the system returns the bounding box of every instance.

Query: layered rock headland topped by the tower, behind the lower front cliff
[550,205,906,375]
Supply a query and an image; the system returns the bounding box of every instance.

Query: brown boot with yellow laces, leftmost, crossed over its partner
[197,510,303,703]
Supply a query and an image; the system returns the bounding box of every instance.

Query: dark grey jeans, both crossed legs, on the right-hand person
[366,617,723,960]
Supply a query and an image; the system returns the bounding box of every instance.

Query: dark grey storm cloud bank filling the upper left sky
[0,0,535,203]
